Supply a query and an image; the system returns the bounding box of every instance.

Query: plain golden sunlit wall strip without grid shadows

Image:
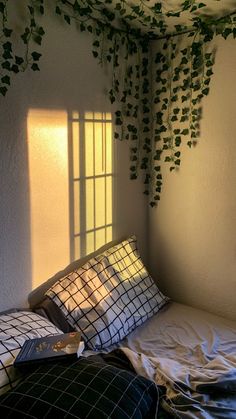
[27,109,69,288]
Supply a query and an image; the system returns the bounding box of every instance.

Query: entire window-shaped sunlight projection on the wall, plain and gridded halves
[27,109,114,288]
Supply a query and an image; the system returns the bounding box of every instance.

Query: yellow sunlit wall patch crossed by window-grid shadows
[71,112,113,258]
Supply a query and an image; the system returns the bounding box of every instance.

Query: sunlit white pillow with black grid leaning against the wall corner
[46,236,168,350]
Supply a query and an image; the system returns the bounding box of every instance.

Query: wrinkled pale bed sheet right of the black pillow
[120,302,236,419]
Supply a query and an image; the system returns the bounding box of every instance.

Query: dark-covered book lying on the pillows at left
[14,332,84,367]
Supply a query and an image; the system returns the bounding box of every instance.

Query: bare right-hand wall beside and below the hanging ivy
[149,39,236,319]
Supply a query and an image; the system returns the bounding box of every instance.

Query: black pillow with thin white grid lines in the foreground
[0,356,159,419]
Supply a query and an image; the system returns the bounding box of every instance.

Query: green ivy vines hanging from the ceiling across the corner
[0,0,236,206]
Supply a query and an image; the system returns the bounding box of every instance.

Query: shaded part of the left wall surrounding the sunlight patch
[0,10,147,310]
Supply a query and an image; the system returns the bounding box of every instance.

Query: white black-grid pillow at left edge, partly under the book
[0,311,62,394]
